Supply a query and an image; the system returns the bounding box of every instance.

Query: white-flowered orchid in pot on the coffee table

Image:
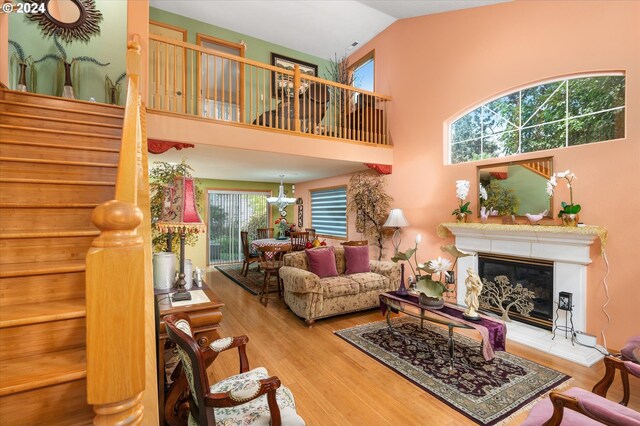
[391,234,468,299]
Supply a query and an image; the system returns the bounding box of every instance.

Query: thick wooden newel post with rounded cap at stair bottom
[86,200,145,425]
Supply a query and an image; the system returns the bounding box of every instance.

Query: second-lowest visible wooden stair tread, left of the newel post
[0,299,87,329]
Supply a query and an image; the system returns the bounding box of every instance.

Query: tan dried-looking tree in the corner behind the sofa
[347,172,392,260]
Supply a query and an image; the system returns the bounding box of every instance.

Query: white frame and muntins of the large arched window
[444,70,627,165]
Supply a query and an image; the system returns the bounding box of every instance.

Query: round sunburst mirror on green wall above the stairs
[27,0,102,43]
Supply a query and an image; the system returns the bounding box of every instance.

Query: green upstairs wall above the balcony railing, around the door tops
[149,5,329,78]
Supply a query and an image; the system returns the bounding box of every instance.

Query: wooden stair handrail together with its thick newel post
[86,41,155,425]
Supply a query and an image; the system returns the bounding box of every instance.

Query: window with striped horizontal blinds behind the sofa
[311,187,347,238]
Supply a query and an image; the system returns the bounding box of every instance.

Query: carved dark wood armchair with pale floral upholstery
[164,314,305,426]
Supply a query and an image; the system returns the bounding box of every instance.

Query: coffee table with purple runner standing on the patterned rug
[380,292,506,371]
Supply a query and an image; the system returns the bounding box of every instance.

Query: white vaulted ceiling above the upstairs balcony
[150,0,511,59]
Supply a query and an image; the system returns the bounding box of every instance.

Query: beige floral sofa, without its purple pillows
[280,247,400,325]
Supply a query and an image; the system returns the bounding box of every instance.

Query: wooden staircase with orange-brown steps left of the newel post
[0,89,123,425]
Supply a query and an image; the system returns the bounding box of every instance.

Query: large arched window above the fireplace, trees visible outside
[448,73,625,164]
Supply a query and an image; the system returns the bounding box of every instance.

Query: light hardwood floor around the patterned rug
[207,268,640,426]
